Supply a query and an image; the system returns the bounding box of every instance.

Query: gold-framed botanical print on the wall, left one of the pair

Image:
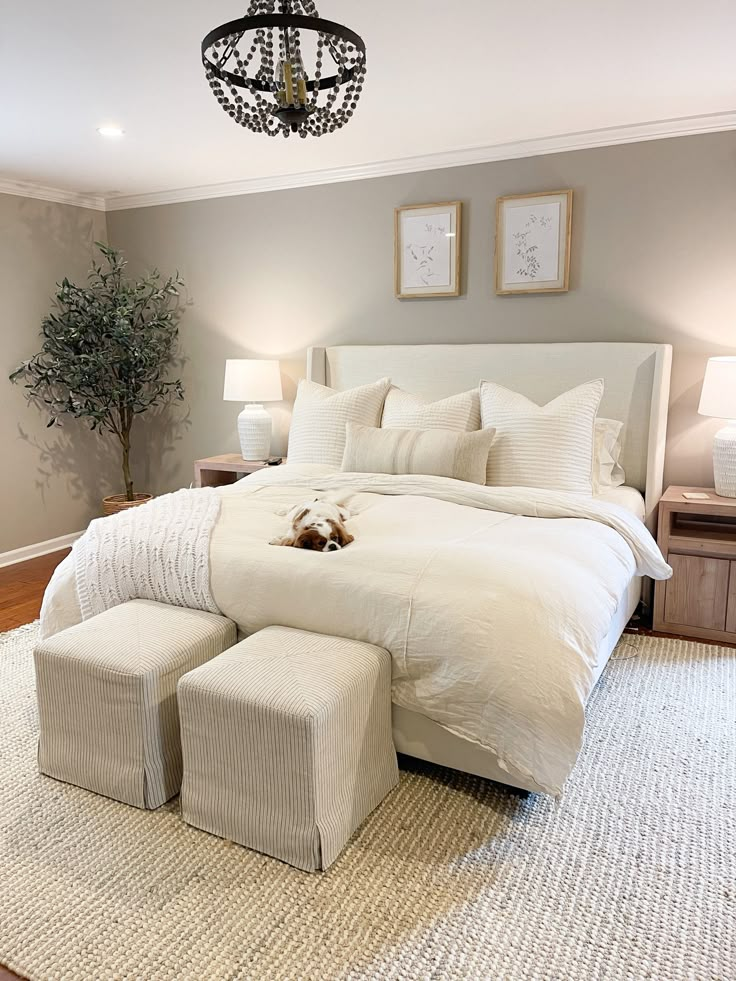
[394,201,461,299]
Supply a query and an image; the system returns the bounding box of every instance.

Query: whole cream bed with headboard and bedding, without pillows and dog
[42,343,671,794]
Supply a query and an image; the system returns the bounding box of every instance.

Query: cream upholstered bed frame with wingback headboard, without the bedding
[307,343,672,791]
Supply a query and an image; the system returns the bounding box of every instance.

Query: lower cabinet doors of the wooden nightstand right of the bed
[664,553,736,630]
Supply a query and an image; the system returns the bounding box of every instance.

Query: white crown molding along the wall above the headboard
[105,111,736,211]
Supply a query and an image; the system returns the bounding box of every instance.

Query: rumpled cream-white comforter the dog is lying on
[42,467,671,794]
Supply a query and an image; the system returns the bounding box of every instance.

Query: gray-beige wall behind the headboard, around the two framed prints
[107,133,736,498]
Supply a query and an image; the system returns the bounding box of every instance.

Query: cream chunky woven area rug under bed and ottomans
[0,626,736,981]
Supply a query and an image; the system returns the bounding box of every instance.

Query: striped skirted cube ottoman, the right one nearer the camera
[179,627,399,871]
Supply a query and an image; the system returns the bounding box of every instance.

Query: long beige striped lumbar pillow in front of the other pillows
[342,423,494,484]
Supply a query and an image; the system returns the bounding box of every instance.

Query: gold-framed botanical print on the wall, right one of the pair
[495,191,572,293]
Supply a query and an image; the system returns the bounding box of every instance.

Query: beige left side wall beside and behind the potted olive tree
[0,194,113,553]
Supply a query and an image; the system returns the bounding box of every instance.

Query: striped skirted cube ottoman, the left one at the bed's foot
[34,600,237,808]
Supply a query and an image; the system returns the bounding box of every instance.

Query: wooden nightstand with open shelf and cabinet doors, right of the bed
[653,487,736,644]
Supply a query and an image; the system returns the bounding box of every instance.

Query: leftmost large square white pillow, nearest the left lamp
[288,378,391,467]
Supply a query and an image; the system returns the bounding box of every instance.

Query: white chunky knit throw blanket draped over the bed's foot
[73,487,226,620]
